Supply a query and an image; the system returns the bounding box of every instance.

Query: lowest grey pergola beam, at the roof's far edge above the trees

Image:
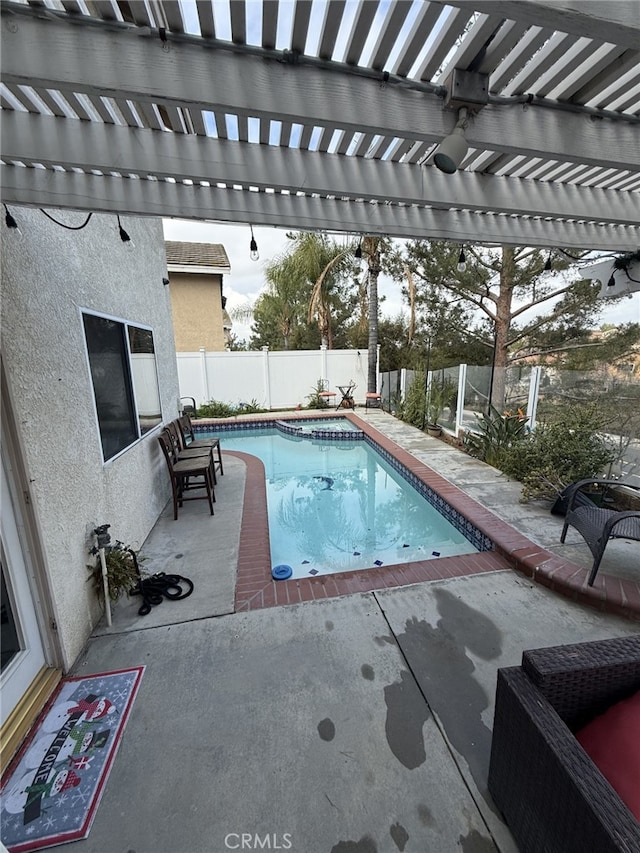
[0,165,640,251]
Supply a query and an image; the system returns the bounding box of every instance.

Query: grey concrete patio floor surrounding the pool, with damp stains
[77,411,638,853]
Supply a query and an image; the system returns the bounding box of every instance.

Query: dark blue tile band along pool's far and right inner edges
[193,418,495,551]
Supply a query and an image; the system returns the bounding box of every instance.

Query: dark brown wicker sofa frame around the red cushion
[489,635,640,853]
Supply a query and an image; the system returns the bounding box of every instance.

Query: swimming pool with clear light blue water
[200,418,492,578]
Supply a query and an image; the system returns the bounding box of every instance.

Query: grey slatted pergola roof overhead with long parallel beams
[1,0,640,252]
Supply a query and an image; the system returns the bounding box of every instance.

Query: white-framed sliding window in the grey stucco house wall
[82,313,162,462]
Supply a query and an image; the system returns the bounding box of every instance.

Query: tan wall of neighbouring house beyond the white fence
[169,271,225,352]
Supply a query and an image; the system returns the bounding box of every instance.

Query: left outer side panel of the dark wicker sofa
[488,667,640,853]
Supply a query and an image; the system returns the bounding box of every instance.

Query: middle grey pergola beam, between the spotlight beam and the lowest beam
[1,111,640,225]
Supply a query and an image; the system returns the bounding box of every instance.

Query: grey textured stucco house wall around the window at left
[0,206,179,668]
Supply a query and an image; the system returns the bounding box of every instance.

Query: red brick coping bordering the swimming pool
[201,412,640,619]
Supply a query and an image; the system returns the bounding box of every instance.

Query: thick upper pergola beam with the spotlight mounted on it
[1,10,640,171]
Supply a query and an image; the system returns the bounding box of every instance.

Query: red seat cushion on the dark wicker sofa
[576,690,640,821]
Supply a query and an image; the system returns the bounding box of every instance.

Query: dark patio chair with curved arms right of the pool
[560,479,640,586]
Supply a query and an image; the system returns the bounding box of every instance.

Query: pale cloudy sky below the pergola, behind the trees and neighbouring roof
[163,219,640,341]
